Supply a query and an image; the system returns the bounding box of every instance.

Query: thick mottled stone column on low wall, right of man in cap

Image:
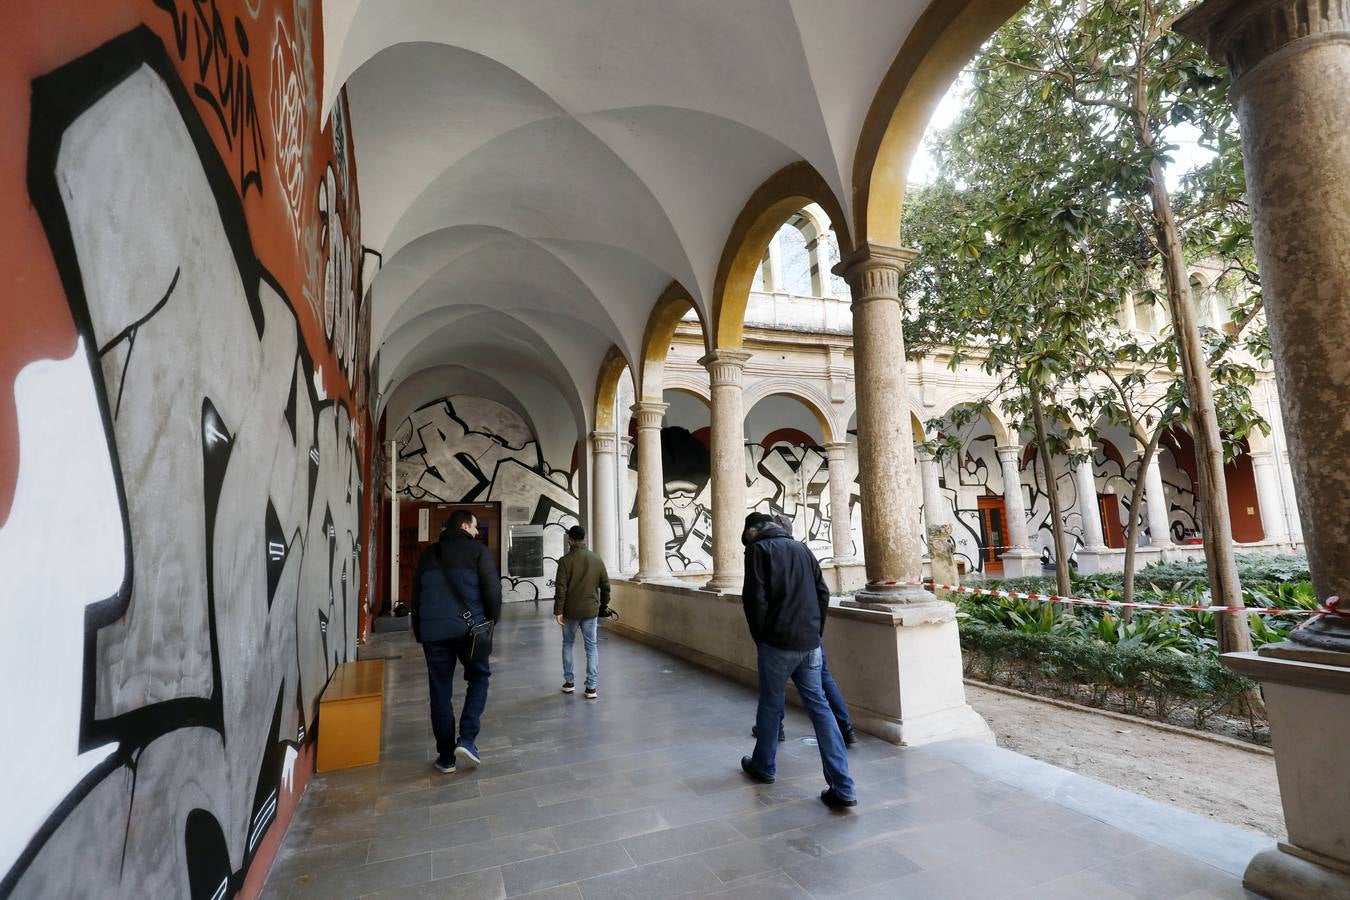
[836,244,933,602]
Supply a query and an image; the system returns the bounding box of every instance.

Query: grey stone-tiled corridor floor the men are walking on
[265,604,1269,900]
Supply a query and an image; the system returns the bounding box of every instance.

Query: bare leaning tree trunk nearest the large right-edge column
[1149,159,1251,653]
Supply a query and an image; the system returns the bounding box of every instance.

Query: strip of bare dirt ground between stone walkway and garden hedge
[965,684,1285,838]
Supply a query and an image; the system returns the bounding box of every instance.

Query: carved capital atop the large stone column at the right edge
[1173,0,1350,86]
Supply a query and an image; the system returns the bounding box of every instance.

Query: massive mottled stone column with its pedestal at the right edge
[1176,0,1350,897]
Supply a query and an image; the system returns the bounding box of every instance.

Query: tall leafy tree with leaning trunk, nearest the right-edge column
[907,0,1264,650]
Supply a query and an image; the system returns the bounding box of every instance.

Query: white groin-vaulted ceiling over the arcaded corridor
[324,0,988,443]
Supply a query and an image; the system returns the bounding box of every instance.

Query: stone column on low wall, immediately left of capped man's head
[698,349,751,591]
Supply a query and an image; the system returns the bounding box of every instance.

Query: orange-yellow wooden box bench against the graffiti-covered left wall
[317,660,385,772]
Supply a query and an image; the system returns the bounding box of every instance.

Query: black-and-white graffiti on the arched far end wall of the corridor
[394,397,581,600]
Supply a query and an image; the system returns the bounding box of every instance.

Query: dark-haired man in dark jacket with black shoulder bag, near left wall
[412,510,502,773]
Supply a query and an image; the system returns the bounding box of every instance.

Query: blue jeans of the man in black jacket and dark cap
[751,644,856,800]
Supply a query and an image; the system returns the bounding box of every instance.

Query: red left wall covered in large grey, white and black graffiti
[0,0,370,897]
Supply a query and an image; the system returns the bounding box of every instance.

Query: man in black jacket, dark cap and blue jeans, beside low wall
[741,513,857,808]
